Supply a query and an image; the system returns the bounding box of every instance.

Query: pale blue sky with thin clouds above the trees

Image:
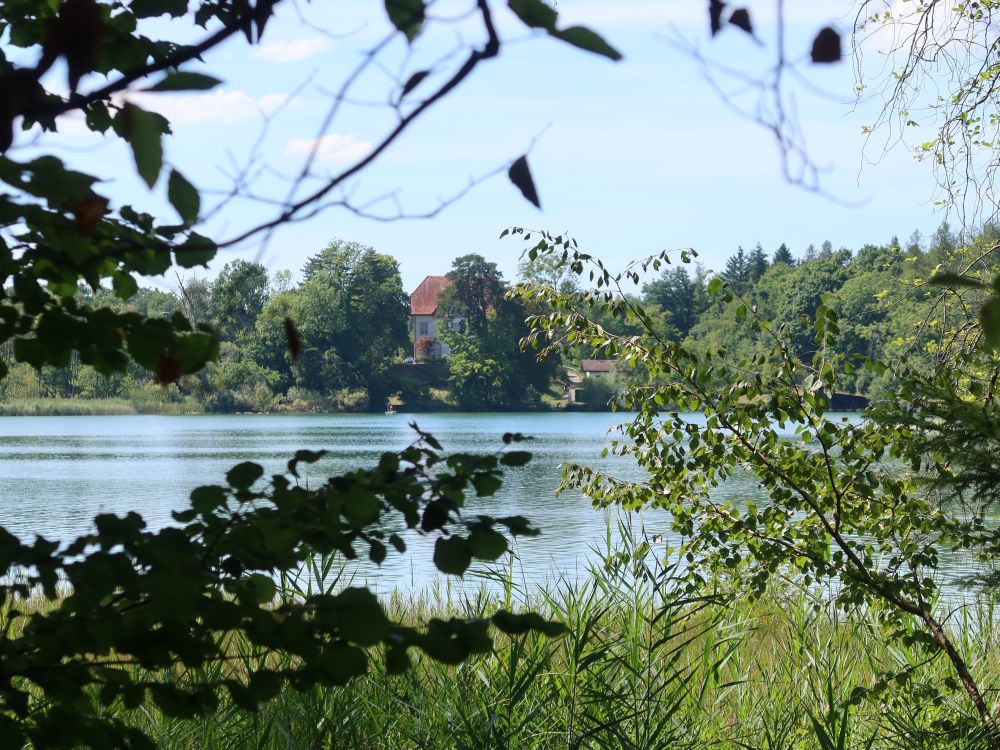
[11,0,946,291]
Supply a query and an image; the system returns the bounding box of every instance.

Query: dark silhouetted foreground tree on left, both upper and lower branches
[0,0,620,747]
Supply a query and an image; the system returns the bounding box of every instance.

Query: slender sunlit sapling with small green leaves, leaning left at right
[515,230,1000,735]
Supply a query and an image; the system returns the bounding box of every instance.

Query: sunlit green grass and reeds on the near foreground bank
[25,556,1000,750]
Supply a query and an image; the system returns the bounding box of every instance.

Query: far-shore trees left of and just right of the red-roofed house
[0,240,557,412]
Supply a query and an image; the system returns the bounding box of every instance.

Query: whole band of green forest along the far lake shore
[0,229,968,413]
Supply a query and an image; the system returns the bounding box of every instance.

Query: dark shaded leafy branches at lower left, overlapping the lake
[0,433,560,747]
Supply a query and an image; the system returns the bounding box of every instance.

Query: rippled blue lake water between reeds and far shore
[0,412,976,593]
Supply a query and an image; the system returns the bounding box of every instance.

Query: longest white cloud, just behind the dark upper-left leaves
[122,89,290,125]
